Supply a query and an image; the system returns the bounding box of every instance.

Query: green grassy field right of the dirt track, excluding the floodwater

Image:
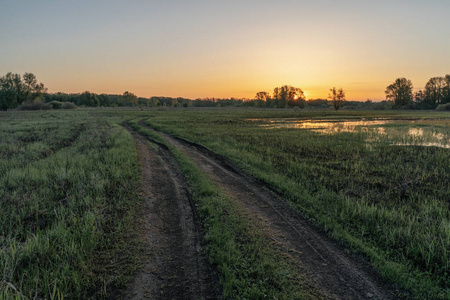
[147,110,450,299]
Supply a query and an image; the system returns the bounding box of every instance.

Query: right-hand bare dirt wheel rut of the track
[140,122,396,299]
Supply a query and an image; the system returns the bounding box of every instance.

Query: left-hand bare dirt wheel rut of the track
[123,123,220,299]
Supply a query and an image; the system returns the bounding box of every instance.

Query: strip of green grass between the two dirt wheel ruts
[130,119,324,299]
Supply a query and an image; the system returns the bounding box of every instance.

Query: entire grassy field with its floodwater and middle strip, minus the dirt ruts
[0,109,450,299]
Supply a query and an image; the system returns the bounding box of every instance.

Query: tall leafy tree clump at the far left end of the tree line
[0,72,47,110]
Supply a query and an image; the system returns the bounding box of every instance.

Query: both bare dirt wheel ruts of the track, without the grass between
[124,122,395,299]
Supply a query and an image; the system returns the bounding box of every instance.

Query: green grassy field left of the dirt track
[0,111,141,299]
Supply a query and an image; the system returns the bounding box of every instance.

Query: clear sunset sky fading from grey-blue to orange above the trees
[0,0,450,101]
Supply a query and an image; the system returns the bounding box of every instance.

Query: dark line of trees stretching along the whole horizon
[0,72,450,110]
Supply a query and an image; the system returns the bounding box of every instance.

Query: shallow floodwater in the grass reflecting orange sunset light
[249,118,450,149]
